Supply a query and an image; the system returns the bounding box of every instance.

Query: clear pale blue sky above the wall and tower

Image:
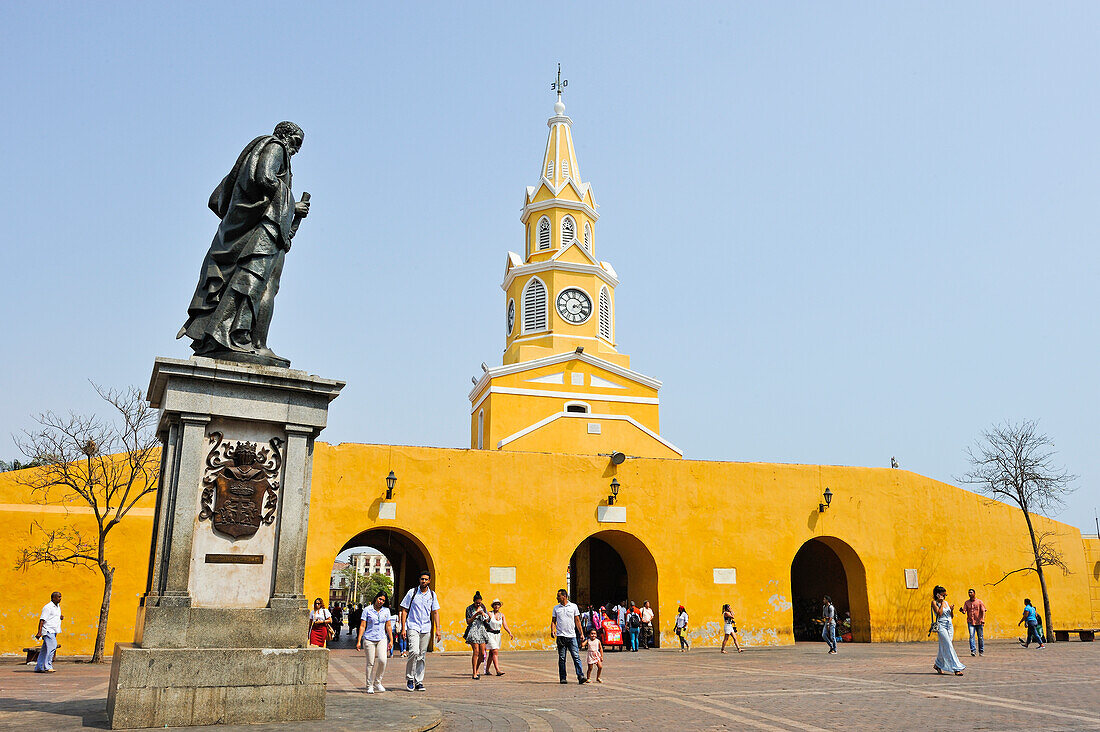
[0,2,1100,533]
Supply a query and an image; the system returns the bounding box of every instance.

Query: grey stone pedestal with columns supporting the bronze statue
[107,358,343,729]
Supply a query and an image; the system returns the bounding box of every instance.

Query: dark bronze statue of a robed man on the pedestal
[176,122,309,367]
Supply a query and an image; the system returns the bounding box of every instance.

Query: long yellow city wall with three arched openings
[0,444,1100,655]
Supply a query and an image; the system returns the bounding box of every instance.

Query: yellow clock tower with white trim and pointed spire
[470,74,682,458]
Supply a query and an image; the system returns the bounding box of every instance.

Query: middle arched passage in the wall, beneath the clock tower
[569,531,660,645]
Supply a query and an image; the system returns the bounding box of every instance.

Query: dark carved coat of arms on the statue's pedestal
[199,433,283,538]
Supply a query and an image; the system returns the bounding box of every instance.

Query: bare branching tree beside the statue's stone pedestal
[15,384,160,663]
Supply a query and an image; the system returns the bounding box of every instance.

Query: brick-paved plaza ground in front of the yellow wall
[0,641,1100,731]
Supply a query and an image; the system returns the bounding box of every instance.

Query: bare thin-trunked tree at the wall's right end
[958,420,1077,636]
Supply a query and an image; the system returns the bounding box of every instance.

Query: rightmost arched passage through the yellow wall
[791,536,871,643]
